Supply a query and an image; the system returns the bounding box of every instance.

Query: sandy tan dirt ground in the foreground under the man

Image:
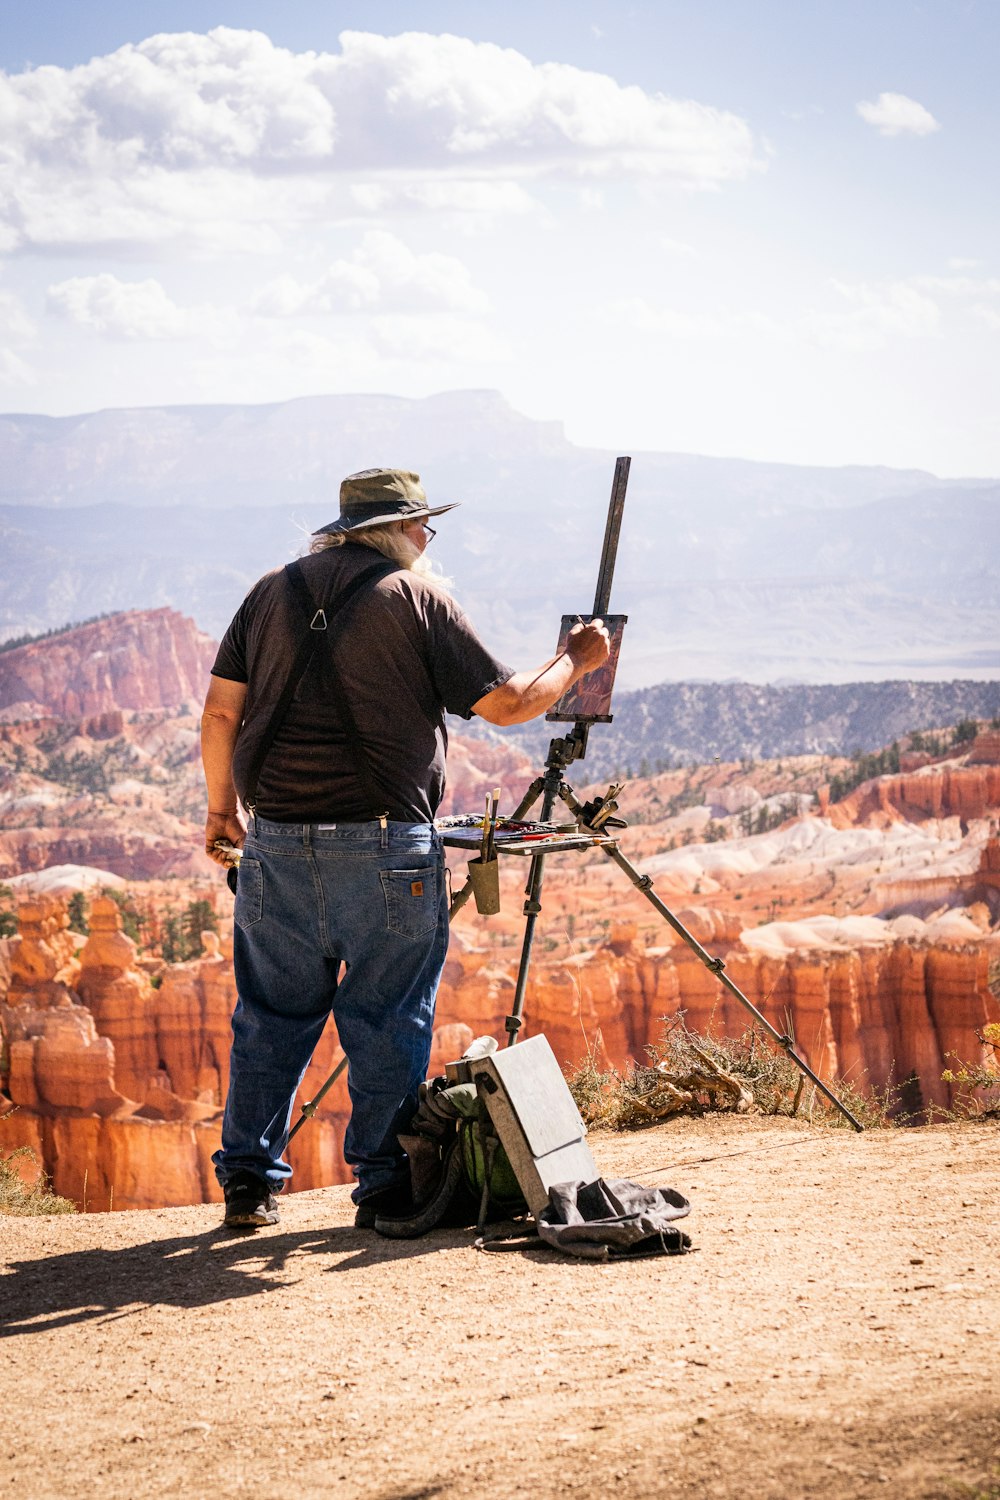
[0,1116,1000,1500]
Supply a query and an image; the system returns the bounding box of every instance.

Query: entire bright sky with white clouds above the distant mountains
[0,0,1000,476]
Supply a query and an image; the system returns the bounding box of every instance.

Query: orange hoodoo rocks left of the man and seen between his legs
[0,897,349,1209]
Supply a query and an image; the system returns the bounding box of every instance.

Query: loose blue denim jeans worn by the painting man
[213,818,448,1202]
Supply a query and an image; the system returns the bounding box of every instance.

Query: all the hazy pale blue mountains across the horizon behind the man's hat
[0,392,1000,687]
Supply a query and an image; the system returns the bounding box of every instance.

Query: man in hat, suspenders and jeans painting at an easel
[202,470,609,1227]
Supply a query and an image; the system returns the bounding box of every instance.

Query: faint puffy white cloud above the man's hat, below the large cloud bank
[253,230,487,318]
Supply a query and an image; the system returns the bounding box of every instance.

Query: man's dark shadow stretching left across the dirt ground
[0,1226,497,1338]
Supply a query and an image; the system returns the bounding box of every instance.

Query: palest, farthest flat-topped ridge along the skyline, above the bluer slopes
[0,390,996,512]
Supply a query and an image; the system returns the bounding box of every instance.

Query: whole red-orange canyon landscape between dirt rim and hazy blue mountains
[0,611,1000,1211]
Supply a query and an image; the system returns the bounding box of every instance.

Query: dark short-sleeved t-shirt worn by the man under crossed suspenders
[211,543,513,824]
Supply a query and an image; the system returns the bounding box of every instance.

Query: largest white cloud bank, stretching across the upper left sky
[0,27,762,249]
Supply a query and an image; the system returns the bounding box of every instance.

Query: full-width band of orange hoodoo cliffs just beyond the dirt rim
[0,897,1000,1211]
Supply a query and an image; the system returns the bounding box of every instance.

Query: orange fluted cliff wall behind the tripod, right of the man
[439,912,1000,1109]
